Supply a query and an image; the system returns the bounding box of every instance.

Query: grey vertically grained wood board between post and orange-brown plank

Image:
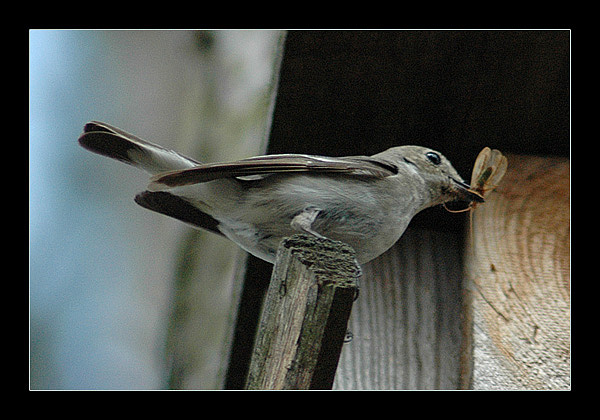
[334,227,462,390]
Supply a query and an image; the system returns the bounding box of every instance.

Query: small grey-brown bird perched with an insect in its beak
[79,121,483,264]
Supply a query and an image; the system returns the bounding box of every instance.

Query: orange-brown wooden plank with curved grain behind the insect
[465,155,570,389]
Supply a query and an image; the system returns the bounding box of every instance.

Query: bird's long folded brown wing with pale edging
[151,154,398,188]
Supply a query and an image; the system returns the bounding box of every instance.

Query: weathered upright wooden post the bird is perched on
[246,235,360,389]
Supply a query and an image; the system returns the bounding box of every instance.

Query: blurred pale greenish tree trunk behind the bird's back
[166,31,285,389]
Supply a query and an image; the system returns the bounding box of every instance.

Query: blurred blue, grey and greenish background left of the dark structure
[29,30,284,389]
